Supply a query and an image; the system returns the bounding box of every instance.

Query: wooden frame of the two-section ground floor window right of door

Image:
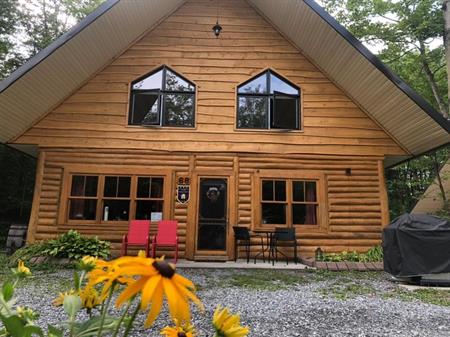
[252,170,328,233]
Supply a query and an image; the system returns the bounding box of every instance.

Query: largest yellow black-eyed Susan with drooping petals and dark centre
[116,257,203,327]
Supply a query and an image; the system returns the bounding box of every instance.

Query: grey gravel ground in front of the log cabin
[9,270,450,337]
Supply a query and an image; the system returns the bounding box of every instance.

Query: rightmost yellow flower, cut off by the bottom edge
[213,305,250,337]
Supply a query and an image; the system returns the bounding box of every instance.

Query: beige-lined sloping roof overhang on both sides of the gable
[0,0,450,165]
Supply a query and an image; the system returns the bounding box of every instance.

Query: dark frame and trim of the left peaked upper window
[126,64,198,130]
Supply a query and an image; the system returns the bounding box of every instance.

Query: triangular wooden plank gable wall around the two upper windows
[14,0,407,156]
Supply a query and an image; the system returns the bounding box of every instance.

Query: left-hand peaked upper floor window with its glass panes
[128,66,195,127]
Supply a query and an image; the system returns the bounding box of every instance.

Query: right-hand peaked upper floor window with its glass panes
[237,70,300,130]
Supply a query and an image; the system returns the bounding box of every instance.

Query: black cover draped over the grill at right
[383,213,450,277]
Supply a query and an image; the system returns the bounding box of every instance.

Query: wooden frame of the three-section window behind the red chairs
[57,164,173,228]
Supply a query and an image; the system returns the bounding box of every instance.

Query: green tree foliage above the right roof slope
[322,0,447,114]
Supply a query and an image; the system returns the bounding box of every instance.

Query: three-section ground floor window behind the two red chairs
[67,174,164,222]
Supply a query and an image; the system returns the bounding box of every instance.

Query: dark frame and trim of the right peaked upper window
[234,68,303,132]
